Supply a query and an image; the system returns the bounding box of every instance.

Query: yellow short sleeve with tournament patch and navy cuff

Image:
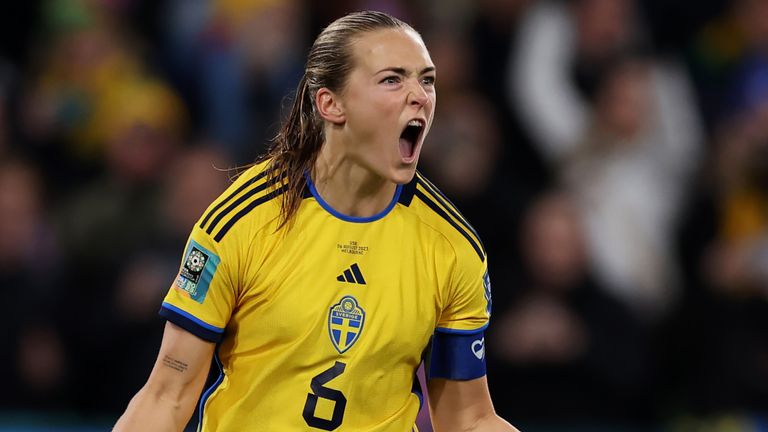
[160,226,237,342]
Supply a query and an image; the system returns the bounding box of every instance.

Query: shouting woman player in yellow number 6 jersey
[116,12,515,431]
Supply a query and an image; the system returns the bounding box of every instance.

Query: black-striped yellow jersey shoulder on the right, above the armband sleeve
[399,171,486,263]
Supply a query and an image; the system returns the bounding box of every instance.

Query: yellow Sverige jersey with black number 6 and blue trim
[160,162,490,432]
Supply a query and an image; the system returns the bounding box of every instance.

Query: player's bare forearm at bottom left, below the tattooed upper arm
[114,384,197,432]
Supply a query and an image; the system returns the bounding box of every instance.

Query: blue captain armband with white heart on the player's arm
[427,326,486,381]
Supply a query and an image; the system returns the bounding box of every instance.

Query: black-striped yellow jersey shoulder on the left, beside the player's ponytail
[195,161,284,243]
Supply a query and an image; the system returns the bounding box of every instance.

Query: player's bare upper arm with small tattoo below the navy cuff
[147,322,216,405]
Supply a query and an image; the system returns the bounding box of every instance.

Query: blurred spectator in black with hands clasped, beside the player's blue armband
[489,191,650,428]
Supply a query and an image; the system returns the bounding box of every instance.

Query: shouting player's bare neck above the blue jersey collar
[312,142,397,217]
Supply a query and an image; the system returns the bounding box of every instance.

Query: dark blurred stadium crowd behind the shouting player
[0,0,768,432]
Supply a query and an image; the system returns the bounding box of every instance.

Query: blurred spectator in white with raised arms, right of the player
[510,0,701,322]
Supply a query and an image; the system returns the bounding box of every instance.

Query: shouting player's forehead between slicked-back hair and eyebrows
[352,29,434,73]
